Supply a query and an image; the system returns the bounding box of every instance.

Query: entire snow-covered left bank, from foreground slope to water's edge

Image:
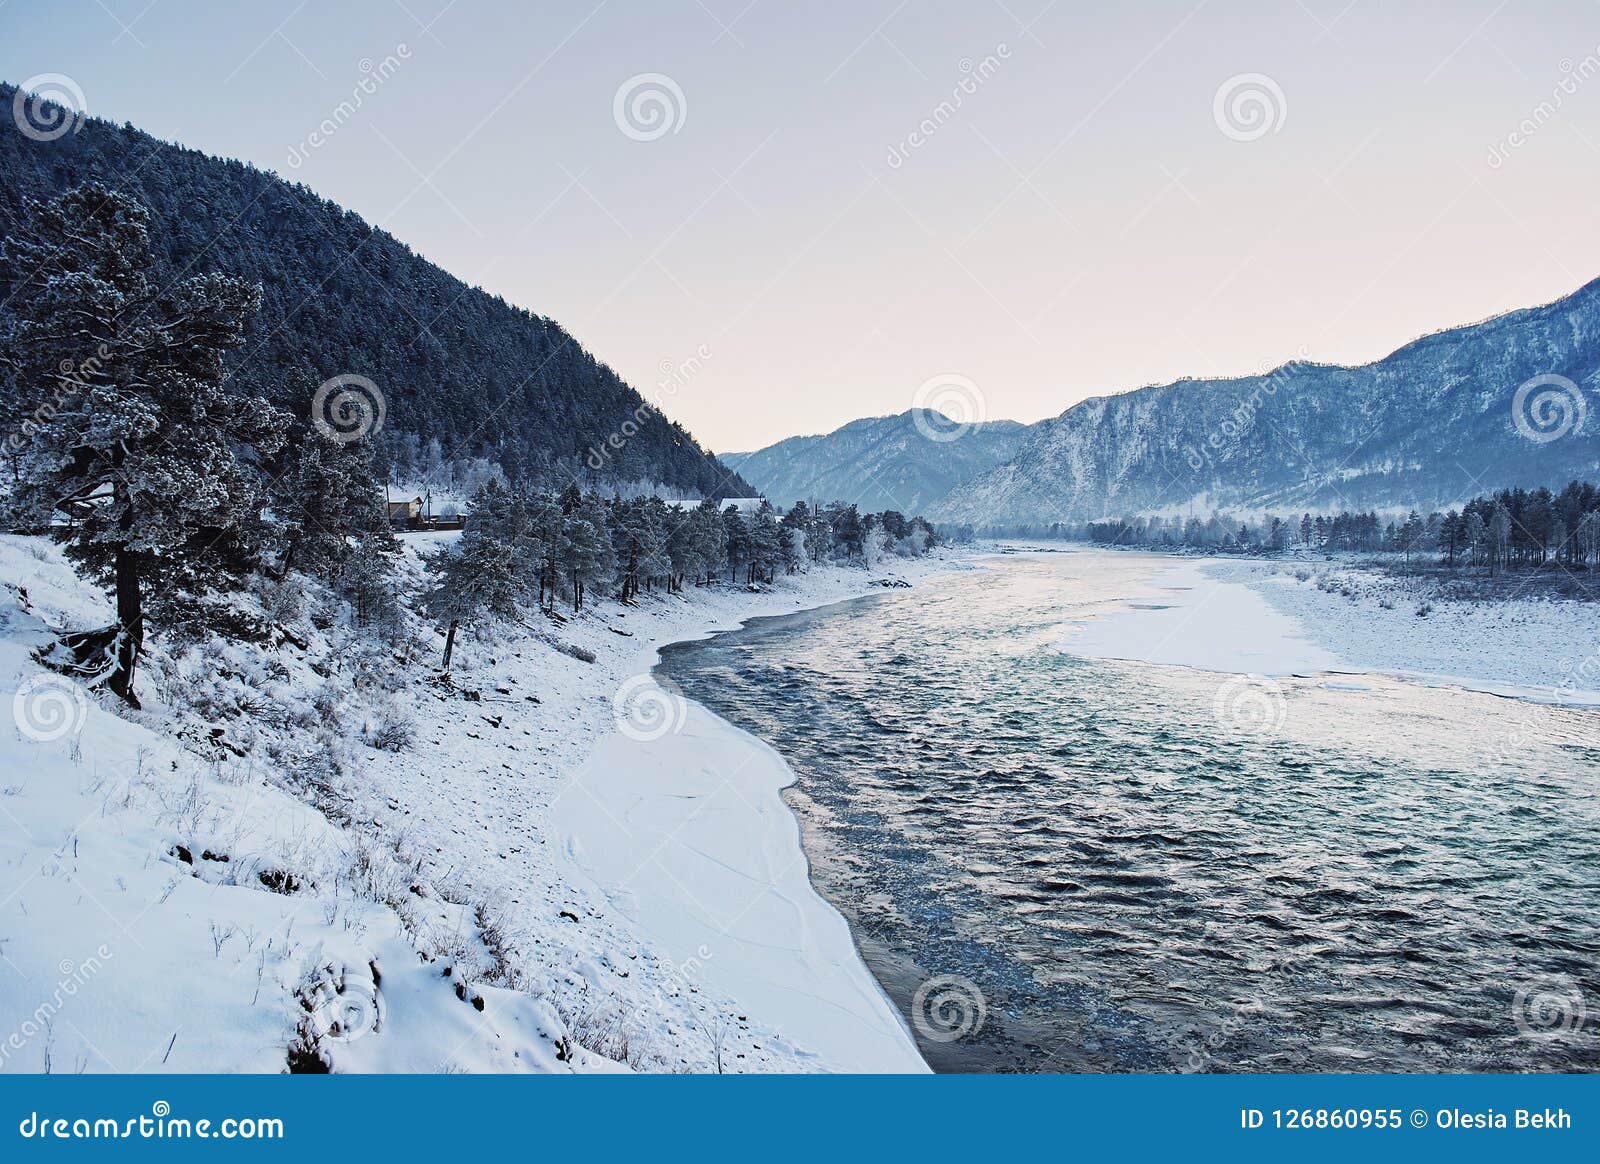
[0,534,963,1071]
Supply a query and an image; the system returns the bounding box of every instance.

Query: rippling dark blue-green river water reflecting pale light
[661,552,1600,1071]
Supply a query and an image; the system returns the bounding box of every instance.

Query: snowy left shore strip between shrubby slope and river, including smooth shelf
[348,558,960,1071]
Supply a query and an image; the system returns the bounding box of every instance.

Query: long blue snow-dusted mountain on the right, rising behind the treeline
[934,280,1600,526]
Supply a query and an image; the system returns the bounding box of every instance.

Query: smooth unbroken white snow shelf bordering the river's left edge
[555,696,926,1071]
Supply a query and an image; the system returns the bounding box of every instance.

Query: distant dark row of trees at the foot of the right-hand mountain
[1062,481,1600,569]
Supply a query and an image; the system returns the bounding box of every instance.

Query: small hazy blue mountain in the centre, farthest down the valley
[722,409,1026,513]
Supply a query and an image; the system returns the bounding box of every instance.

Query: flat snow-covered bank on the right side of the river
[1062,553,1600,705]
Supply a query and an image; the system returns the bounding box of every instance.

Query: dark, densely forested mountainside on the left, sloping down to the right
[0,85,750,497]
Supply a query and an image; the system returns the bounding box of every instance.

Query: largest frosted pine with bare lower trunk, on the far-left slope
[0,185,286,705]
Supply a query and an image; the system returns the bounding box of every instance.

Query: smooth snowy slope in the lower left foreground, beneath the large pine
[0,537,613,1073]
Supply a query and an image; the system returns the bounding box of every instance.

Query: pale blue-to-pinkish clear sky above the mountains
[0,0,1600,451]
